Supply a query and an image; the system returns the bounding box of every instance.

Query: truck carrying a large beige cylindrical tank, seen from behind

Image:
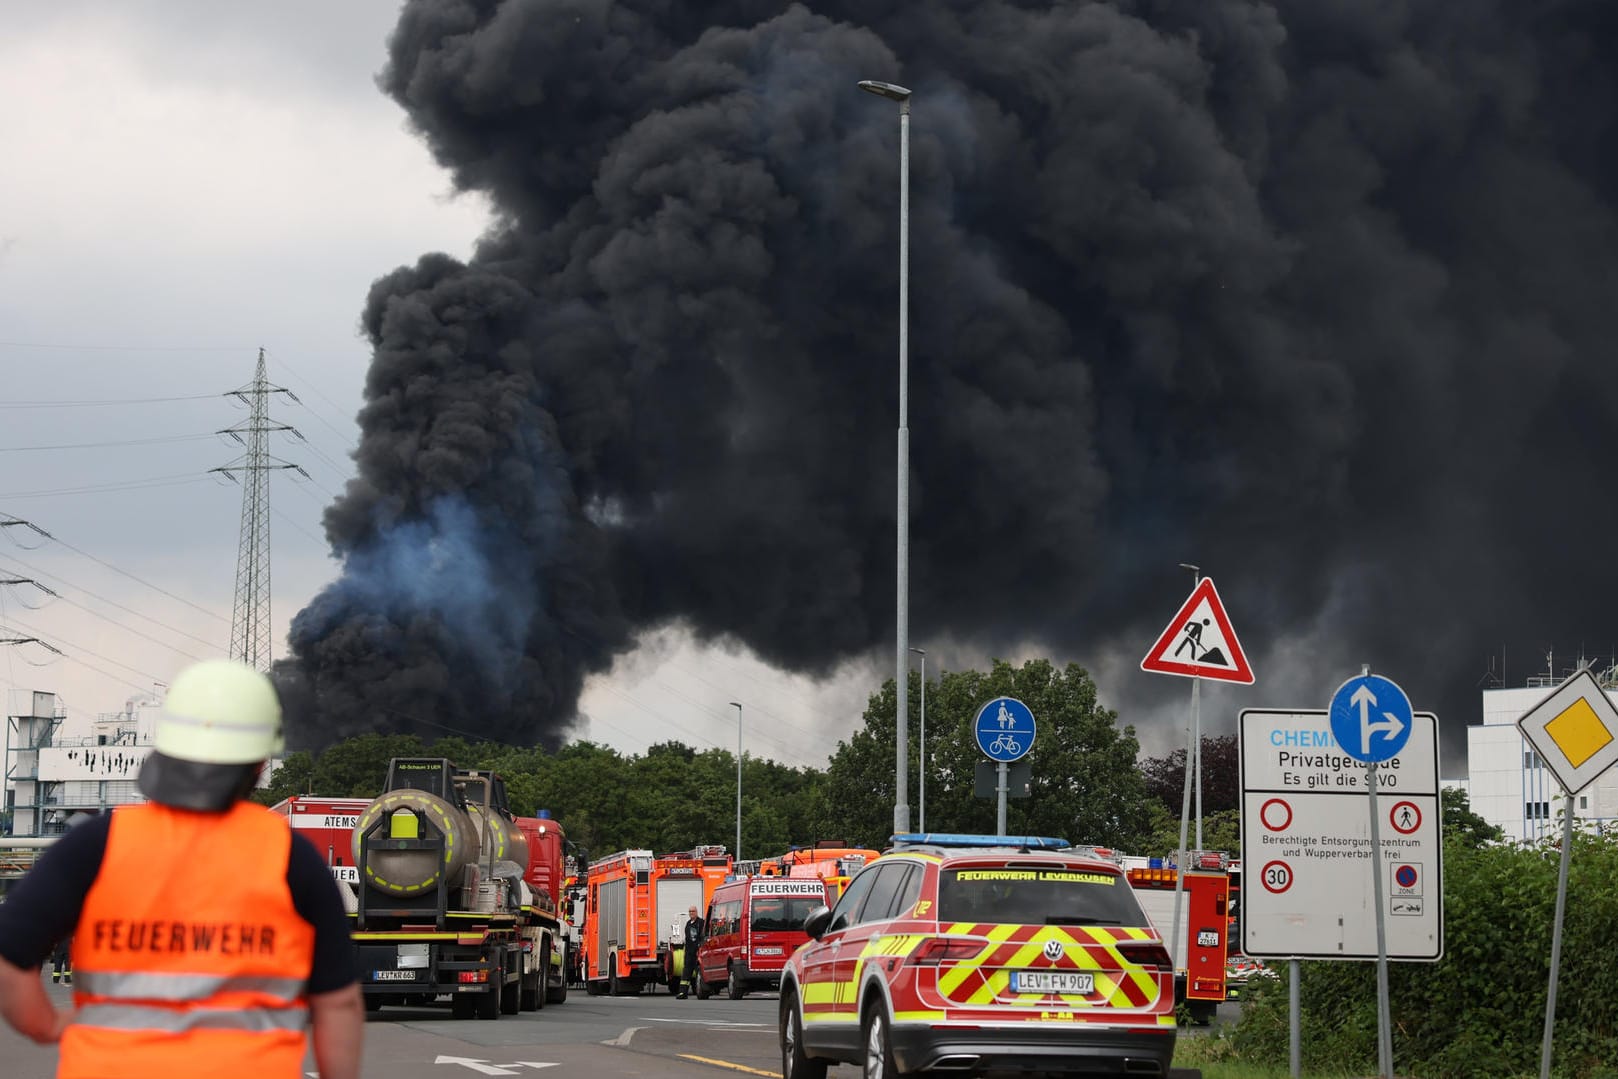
[353,757,568,1019]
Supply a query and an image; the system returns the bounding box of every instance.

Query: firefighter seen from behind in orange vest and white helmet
[0,660,366,1079]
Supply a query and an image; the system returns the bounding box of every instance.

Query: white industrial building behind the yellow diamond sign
[1455,666,1618,840]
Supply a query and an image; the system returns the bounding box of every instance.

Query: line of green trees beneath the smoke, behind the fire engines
[257,660,1262,857]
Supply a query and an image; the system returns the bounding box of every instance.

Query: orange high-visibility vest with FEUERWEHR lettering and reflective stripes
[57,802,314,1079]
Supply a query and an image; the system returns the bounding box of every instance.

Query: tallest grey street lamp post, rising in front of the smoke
[859,79,911,833]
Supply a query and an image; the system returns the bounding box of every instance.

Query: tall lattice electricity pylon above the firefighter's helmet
[209,348,309,671]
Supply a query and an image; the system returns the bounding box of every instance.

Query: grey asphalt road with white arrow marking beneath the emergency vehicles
[0,987,1216,1079]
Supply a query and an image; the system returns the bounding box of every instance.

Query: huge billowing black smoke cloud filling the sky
[285,0,1618,760]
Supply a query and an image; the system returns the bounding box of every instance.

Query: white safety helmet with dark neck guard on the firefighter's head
[141,660,282,810]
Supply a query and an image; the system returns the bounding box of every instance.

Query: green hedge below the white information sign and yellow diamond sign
[1230,835,1618,1079]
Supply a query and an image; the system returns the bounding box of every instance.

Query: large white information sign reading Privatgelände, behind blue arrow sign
[1239,709,1443,961]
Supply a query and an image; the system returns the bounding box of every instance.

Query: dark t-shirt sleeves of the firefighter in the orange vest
[0,814,358,993]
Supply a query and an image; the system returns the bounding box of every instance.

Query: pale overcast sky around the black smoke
[0,0,912,765]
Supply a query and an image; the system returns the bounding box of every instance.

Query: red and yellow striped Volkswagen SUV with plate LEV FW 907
[780,835,1176,1079]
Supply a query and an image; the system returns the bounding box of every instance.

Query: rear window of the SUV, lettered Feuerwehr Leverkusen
[938,865,1149,925]
